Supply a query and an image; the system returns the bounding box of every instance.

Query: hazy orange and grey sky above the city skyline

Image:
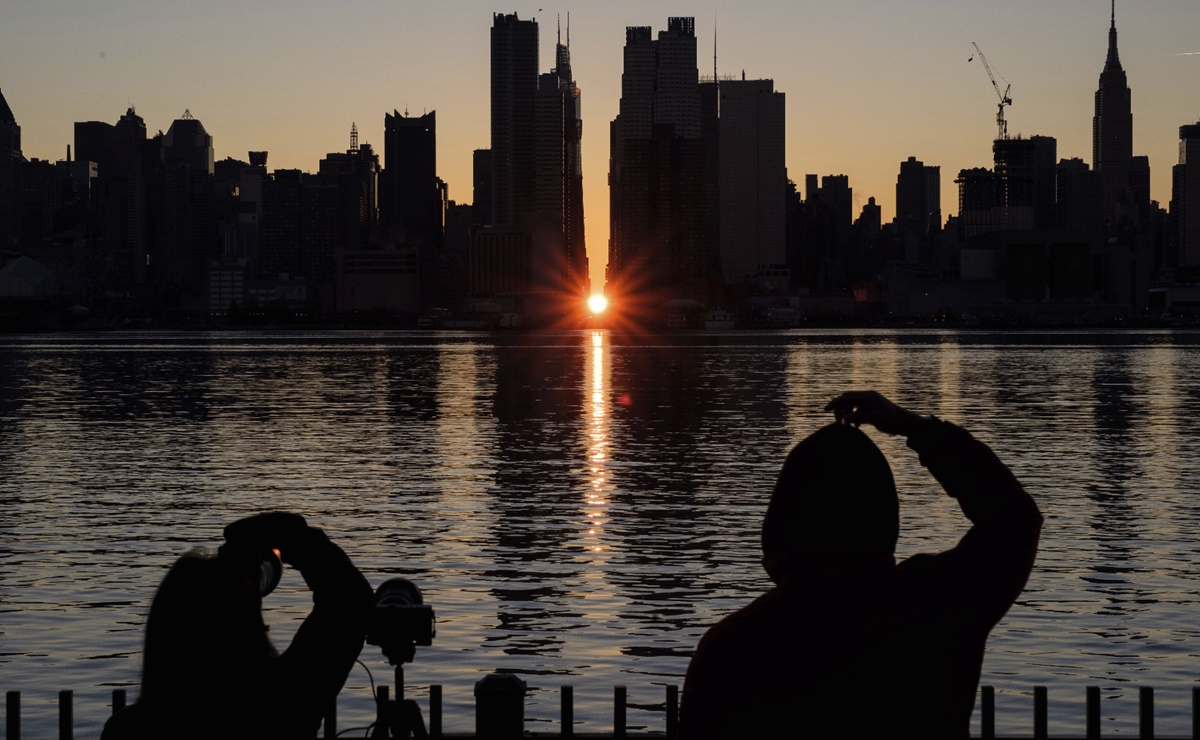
[0,0,1200,290]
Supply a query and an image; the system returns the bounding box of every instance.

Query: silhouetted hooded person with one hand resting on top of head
[679,391,1042,740]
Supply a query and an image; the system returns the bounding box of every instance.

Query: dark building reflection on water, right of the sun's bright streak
[610,336,787,657]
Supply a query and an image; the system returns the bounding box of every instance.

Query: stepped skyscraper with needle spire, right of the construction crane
[1092,0,1133,222]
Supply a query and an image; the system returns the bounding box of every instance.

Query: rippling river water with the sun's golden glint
[0,331,1200,738]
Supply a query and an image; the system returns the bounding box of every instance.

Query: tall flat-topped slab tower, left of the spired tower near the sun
[492,13,538,225]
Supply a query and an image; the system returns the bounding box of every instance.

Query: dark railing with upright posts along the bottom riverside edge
[5,674,1200,740]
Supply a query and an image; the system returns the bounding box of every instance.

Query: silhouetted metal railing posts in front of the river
[5,685,1200,740]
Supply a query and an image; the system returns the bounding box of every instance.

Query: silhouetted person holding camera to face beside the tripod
[101,512,374,740]
